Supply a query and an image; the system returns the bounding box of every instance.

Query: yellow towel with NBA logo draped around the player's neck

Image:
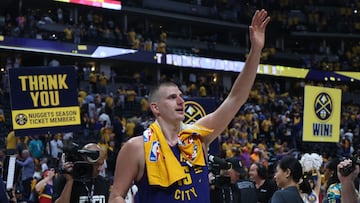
[143,122,213,187]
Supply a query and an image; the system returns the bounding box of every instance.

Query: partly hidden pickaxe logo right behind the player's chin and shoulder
[184,101,206,124]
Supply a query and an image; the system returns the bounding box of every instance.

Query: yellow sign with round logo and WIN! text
[303,86,341,142]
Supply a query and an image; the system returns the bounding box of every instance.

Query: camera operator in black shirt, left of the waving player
[52,143,109,203]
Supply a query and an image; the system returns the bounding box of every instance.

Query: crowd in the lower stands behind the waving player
[0,63,360,201]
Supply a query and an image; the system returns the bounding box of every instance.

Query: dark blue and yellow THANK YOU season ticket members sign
[9,66,80,136]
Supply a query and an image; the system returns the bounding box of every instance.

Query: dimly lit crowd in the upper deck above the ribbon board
[0,0,360,71]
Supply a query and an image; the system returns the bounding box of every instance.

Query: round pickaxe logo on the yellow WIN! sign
[314,92,333,121]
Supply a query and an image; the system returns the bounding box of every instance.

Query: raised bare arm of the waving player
[197,9,270,144]
